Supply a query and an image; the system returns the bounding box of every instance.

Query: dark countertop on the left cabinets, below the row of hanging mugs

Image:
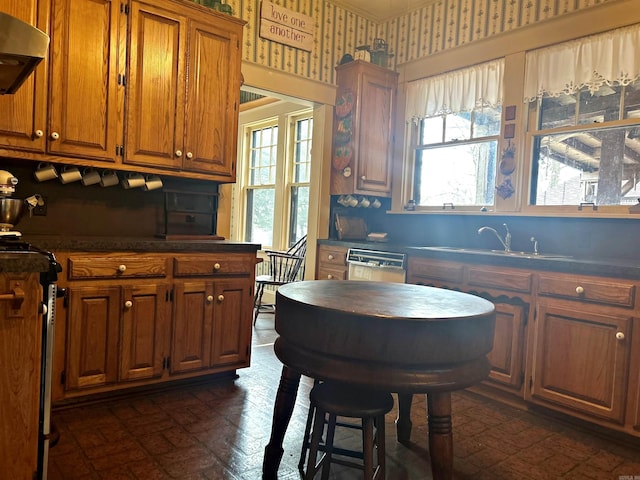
[23,235,260,253]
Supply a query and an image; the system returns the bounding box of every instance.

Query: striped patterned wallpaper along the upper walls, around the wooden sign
[226,0,616,84]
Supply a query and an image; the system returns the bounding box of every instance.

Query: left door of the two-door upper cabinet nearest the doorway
[125,1,187,168]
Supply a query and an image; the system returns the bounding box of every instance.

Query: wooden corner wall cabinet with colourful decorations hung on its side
[331,61,398,196]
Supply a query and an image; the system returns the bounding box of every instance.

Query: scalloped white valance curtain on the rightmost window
[524,24,640,102]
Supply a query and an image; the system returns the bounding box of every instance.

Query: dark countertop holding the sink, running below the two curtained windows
[318,240,640,279]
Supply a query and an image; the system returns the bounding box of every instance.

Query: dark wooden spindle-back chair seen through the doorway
[253,235,307,325]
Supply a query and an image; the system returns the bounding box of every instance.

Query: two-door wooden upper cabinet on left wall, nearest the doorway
[124,2,242,180]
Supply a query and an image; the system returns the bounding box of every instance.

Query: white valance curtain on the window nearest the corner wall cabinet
[405,59,504,122]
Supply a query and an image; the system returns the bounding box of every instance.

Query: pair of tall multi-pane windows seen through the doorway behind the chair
[244,112,313,249]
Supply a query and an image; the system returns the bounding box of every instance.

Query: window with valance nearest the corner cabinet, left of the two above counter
[407,60,504,208]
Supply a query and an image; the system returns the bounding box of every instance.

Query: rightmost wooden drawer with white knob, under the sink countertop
[538,274,636,308]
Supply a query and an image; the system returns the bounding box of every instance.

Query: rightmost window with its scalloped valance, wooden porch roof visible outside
[525,26,640,208]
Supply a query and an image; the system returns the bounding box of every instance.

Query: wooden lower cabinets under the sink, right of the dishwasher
[407,256,640,437]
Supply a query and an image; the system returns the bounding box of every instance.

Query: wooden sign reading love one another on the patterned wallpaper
[260,1,315,52]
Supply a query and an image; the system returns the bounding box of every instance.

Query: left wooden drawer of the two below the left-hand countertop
[67,255,167,280]
